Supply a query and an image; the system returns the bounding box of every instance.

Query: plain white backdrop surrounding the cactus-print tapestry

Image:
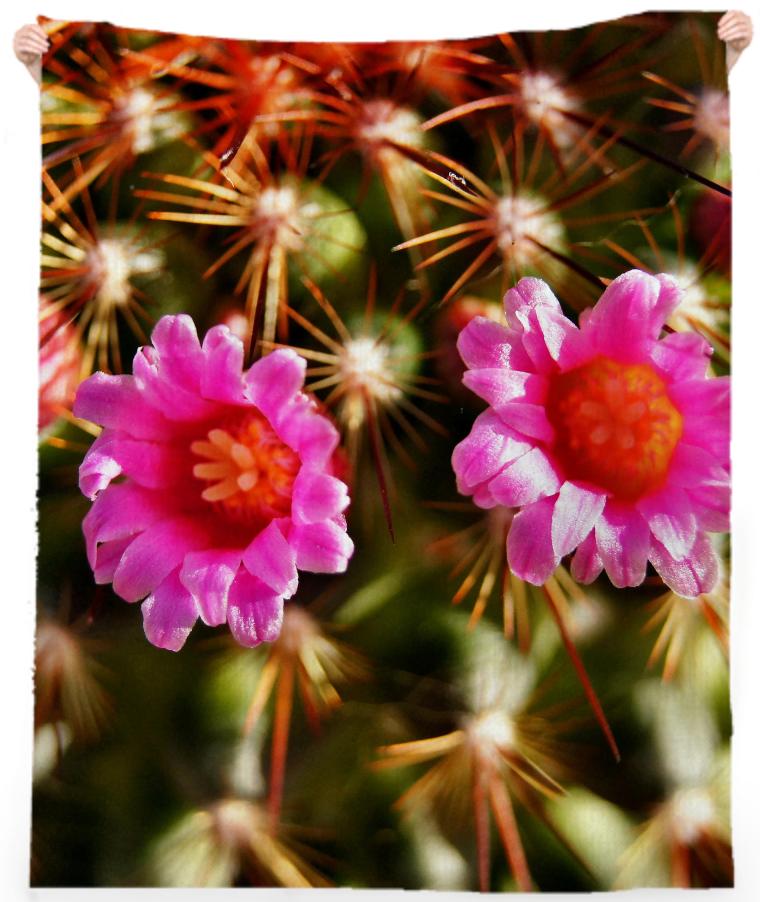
[0,0,760,902]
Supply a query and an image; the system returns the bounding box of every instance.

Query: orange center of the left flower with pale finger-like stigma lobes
[190,410,299,523]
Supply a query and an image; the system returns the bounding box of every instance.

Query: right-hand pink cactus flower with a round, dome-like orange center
[452,270,730,598]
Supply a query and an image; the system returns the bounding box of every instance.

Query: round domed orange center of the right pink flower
[546,357,682,501]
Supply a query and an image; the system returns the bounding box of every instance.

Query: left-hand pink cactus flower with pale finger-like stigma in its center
[74,316,353,651]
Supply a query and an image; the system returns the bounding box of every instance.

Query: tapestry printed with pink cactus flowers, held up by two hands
[31,12,733,891]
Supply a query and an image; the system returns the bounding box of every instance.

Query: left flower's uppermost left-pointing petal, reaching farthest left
[74,373,171,439]
